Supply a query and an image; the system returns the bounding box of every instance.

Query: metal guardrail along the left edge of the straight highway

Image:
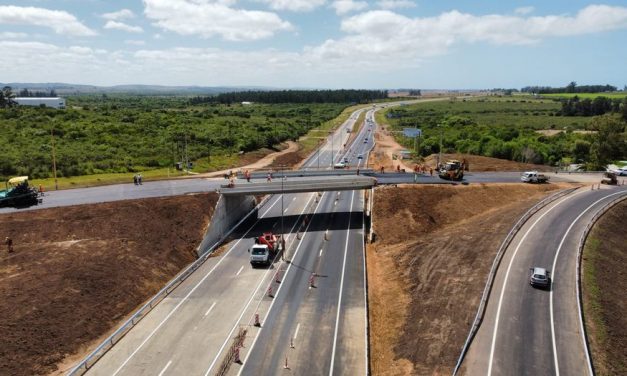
[67,196,270,376]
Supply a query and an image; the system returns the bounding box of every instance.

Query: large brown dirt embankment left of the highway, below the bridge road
[0,193,217,375]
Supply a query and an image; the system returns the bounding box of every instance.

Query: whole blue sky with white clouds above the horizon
[0,0,627,89]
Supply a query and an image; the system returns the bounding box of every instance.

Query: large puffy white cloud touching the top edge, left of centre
[144,0,292,41]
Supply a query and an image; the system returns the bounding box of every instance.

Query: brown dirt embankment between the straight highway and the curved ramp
[367,184,560,375]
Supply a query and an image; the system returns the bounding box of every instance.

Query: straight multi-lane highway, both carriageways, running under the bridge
[78,106,372,375]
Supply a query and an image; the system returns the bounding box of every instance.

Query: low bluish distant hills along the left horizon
[0,82,277,95]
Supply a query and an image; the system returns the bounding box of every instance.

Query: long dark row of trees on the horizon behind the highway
[190,90,388,104]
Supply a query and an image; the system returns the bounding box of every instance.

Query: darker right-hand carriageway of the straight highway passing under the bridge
[237,107,374,375]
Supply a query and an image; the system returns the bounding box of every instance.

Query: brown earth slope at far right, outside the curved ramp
[583,201,627,375]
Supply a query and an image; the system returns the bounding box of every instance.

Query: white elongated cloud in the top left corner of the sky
[0,5,96,36]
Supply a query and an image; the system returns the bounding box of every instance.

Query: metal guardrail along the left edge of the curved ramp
[453,188,578,375]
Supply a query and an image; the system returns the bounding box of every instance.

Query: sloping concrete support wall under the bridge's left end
[196,195,257,257]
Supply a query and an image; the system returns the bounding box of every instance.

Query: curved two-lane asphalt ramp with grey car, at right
[462,187,627,376]
